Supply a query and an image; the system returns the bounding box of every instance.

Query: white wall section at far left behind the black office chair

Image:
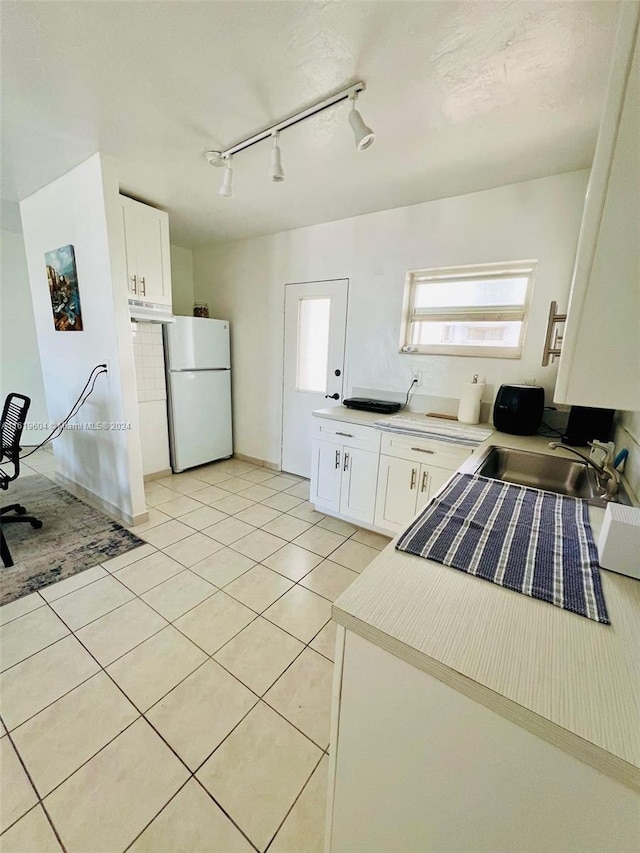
[0,226,49,446]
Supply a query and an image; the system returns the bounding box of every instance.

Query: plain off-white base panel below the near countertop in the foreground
[325,626,638,853]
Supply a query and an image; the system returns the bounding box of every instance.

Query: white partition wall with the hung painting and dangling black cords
[20,154,145,520]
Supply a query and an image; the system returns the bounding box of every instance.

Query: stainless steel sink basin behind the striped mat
[462,447,626,506]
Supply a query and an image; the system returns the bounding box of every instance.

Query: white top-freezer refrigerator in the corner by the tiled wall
[164,317,233,473]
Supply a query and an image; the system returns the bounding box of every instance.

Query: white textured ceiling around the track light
[1,0,619,247]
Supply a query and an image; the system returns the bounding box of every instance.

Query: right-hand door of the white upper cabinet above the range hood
[133,202,171,305]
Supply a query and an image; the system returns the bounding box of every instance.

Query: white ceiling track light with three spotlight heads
[205,81,375,198]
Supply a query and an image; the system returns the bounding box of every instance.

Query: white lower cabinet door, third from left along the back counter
[375,456,421,533]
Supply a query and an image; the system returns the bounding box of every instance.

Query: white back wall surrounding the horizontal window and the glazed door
[194,171,588,470]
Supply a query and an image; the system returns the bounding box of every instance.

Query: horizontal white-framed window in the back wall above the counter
[400,261,535,358]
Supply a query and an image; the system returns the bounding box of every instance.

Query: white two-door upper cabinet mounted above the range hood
[120,195,171,307]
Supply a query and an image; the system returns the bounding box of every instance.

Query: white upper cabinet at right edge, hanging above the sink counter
[554,3,640,410]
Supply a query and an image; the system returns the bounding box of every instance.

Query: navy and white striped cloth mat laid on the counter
[396,474,610,625]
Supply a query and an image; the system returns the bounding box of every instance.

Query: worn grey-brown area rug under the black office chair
[0,474,144,605]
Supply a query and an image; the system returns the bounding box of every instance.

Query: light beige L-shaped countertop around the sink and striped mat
[315,406,640,790]
